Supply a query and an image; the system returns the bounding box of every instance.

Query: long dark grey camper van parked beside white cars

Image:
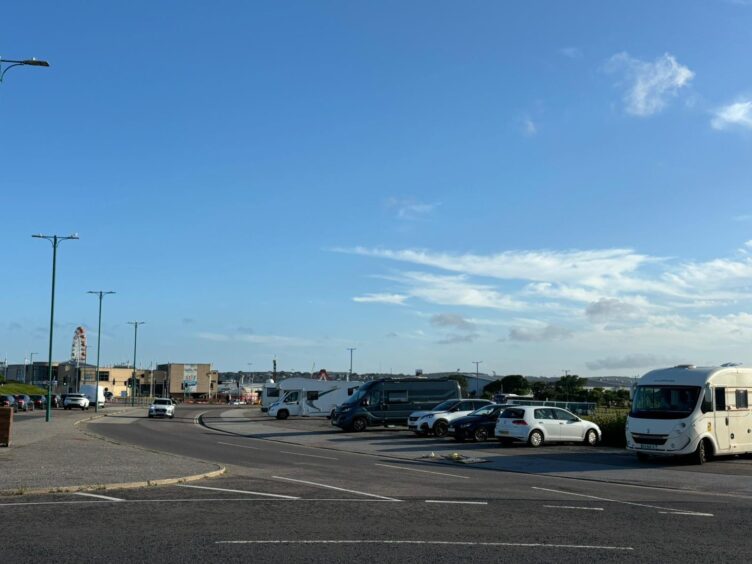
[332,378,461,431]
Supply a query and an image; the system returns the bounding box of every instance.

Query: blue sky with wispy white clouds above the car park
[0,0,752,376]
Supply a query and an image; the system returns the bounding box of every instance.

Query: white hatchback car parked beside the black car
[494,405,601,447]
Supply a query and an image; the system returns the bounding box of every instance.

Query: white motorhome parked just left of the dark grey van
[269,378,360,419]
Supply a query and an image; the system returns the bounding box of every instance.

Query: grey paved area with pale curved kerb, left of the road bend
[0,407,224,495]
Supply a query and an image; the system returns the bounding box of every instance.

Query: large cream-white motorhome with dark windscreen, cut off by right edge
[626,364,752,464]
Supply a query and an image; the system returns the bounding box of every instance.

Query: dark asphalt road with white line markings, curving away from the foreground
[0,407,752,562]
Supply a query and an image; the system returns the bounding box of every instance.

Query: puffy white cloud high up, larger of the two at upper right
[606,53,695,117]
